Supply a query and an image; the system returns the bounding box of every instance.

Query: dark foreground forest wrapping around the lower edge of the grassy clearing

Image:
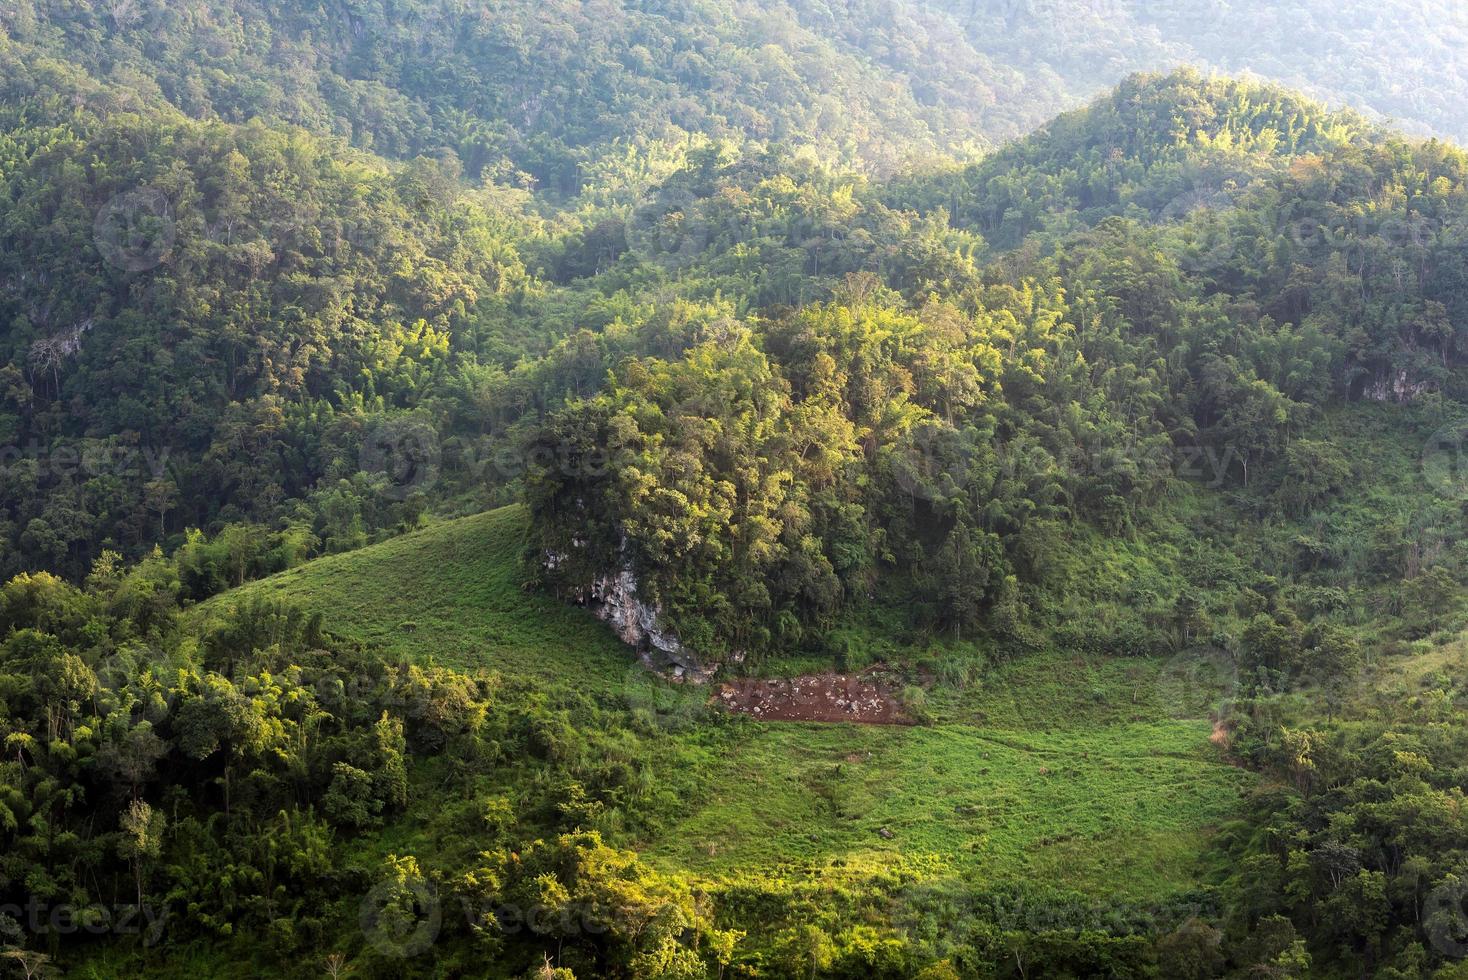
[0,531,1468,979]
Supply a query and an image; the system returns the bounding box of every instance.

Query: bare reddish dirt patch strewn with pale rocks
[713,670,912,725]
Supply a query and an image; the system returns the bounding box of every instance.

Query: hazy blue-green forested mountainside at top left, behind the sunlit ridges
[6,0,994,186]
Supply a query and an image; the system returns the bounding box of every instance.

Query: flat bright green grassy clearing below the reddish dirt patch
[649,722,1252,899]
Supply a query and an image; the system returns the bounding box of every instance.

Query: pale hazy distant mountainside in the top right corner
[895,0,1468,139]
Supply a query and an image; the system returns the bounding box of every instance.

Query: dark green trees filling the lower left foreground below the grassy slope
[0,563,737,977]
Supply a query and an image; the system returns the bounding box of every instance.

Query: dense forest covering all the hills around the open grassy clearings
[0,0,1468,980]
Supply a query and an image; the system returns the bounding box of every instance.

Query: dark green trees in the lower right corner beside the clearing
[1230,692,1468,976]
